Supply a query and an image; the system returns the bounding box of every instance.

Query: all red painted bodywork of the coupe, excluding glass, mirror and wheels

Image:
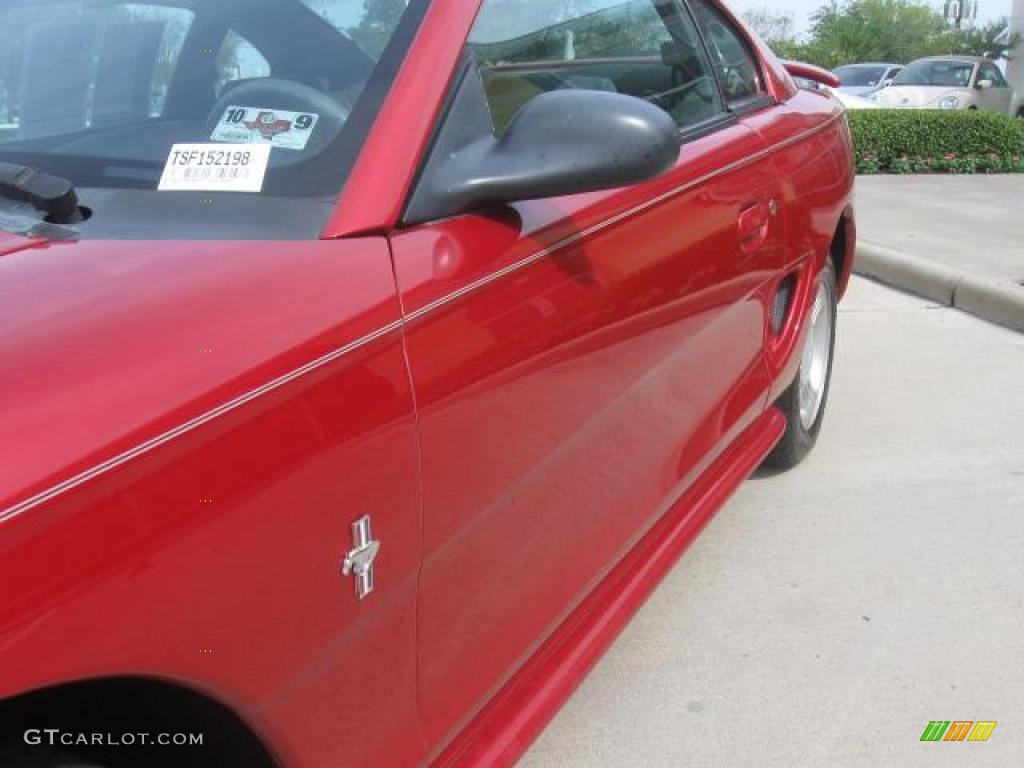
[0,0,855,768]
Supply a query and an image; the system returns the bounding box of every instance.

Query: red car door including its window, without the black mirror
[392,0,783,746]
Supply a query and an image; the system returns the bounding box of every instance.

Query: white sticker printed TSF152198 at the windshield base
[157,144,272,191]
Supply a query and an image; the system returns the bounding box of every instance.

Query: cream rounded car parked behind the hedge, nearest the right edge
[867,56,1024,118]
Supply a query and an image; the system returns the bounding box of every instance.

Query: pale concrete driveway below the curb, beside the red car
[522,280,1024,768]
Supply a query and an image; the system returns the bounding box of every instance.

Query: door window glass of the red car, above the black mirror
[470,0,723,133]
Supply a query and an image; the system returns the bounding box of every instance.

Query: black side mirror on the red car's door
[402,66,681,223]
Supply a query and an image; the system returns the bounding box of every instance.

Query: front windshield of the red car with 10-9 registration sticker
[0,0,422,195]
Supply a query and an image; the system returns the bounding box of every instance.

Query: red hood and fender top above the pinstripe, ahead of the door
[0,241,399,518]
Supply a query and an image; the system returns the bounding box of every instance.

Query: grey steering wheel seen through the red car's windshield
[207,78,352,168]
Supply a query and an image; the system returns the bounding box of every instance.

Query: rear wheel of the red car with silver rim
[764,262,838,470]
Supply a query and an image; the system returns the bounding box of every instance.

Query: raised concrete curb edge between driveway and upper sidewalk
[854,243,1024,333]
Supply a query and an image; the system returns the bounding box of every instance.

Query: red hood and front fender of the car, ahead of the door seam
[0,240,424,766]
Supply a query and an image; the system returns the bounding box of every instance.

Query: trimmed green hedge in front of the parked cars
[848,110,1024,173]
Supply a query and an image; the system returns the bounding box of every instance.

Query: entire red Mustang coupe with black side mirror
[0,0,855,768]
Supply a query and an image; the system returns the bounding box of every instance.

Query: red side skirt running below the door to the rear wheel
[433,408,785,768]
